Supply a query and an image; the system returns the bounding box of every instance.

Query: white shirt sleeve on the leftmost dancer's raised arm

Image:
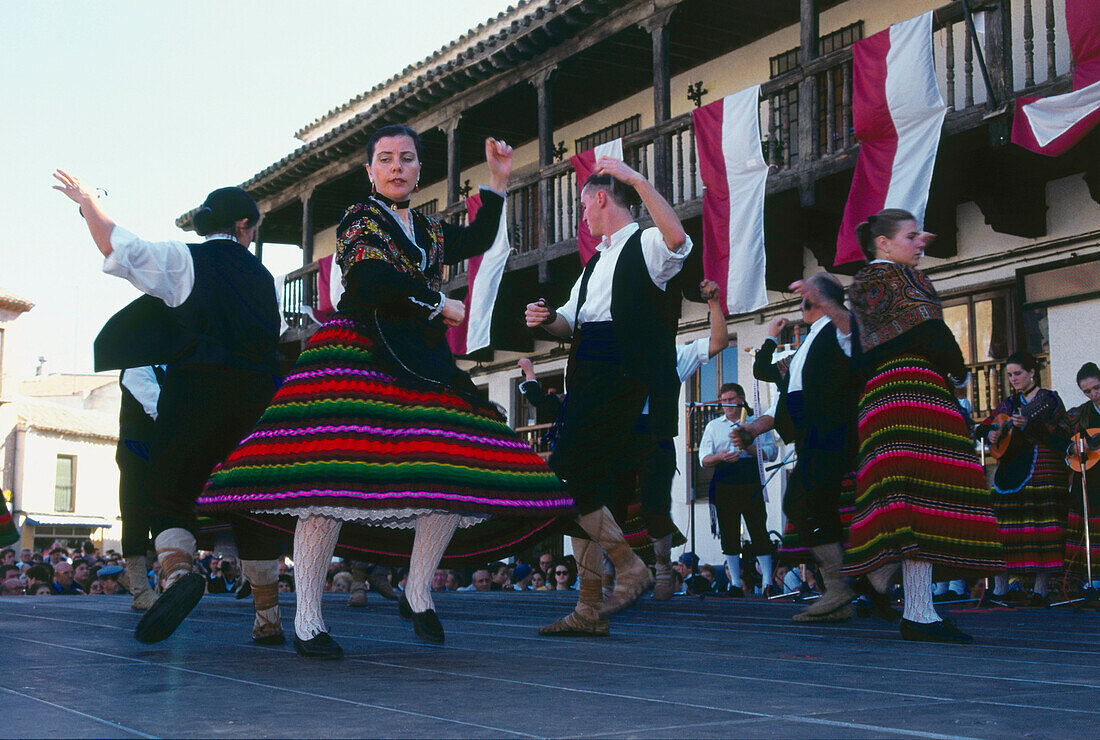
[103,227,195,308]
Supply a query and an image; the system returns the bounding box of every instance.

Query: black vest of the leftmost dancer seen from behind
[95,240,281,373]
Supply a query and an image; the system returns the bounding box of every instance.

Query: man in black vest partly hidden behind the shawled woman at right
[734,273,895,621]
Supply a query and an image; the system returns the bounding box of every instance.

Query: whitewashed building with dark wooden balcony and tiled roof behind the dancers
[177,0,1100,562]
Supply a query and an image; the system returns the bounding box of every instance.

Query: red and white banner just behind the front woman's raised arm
[447,194,512,354]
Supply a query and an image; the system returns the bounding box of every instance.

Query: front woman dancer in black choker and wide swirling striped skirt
[198,125,572,659]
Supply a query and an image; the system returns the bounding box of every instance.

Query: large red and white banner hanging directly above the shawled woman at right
[836,11,947,265]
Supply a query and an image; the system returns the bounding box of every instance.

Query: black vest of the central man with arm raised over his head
[567,229,680,438]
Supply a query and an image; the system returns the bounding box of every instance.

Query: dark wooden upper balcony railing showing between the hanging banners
[285,0,1070,305]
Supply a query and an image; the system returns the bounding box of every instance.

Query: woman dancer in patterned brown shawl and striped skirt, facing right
[845,209,1004,642]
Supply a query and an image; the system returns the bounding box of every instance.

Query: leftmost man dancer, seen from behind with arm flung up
[54,170,285,644]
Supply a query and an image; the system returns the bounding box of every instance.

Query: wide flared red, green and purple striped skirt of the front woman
[196,314,573,566]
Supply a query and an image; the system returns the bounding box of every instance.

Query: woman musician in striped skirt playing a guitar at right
[985,352,1068,606]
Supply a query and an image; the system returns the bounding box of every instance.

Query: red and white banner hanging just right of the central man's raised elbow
[692,85,768,313]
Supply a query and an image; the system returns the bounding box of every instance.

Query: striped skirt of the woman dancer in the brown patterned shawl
[844,355,1004,579]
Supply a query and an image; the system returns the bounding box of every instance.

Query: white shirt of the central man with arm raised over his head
[558,223,692,330]
